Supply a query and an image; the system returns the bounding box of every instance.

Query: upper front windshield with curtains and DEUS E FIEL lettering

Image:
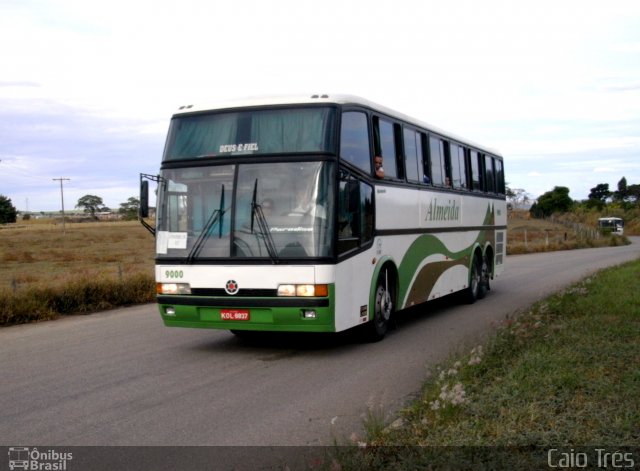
[163,107,336,162]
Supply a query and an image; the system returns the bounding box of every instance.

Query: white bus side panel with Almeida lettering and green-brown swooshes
[376,185,506,309]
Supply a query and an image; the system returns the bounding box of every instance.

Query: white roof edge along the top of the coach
[174,94,501,156]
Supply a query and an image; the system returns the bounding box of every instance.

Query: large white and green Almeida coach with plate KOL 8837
[140,95,507,341]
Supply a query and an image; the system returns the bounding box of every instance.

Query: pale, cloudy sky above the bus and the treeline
[0,0,640,211]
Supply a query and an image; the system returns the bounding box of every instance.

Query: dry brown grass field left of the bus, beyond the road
[0,220,155,325]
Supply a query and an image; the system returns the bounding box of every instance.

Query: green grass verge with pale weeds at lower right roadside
[334,260,640,470]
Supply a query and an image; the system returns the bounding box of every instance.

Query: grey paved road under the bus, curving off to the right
[0,237,640,446]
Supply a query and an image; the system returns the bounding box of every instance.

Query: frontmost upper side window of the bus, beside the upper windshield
[340,111,371,173]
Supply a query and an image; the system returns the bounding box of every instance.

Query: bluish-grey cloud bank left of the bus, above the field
[0,101,166,210]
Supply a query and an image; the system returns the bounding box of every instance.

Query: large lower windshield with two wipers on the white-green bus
[156,162,334,263]
